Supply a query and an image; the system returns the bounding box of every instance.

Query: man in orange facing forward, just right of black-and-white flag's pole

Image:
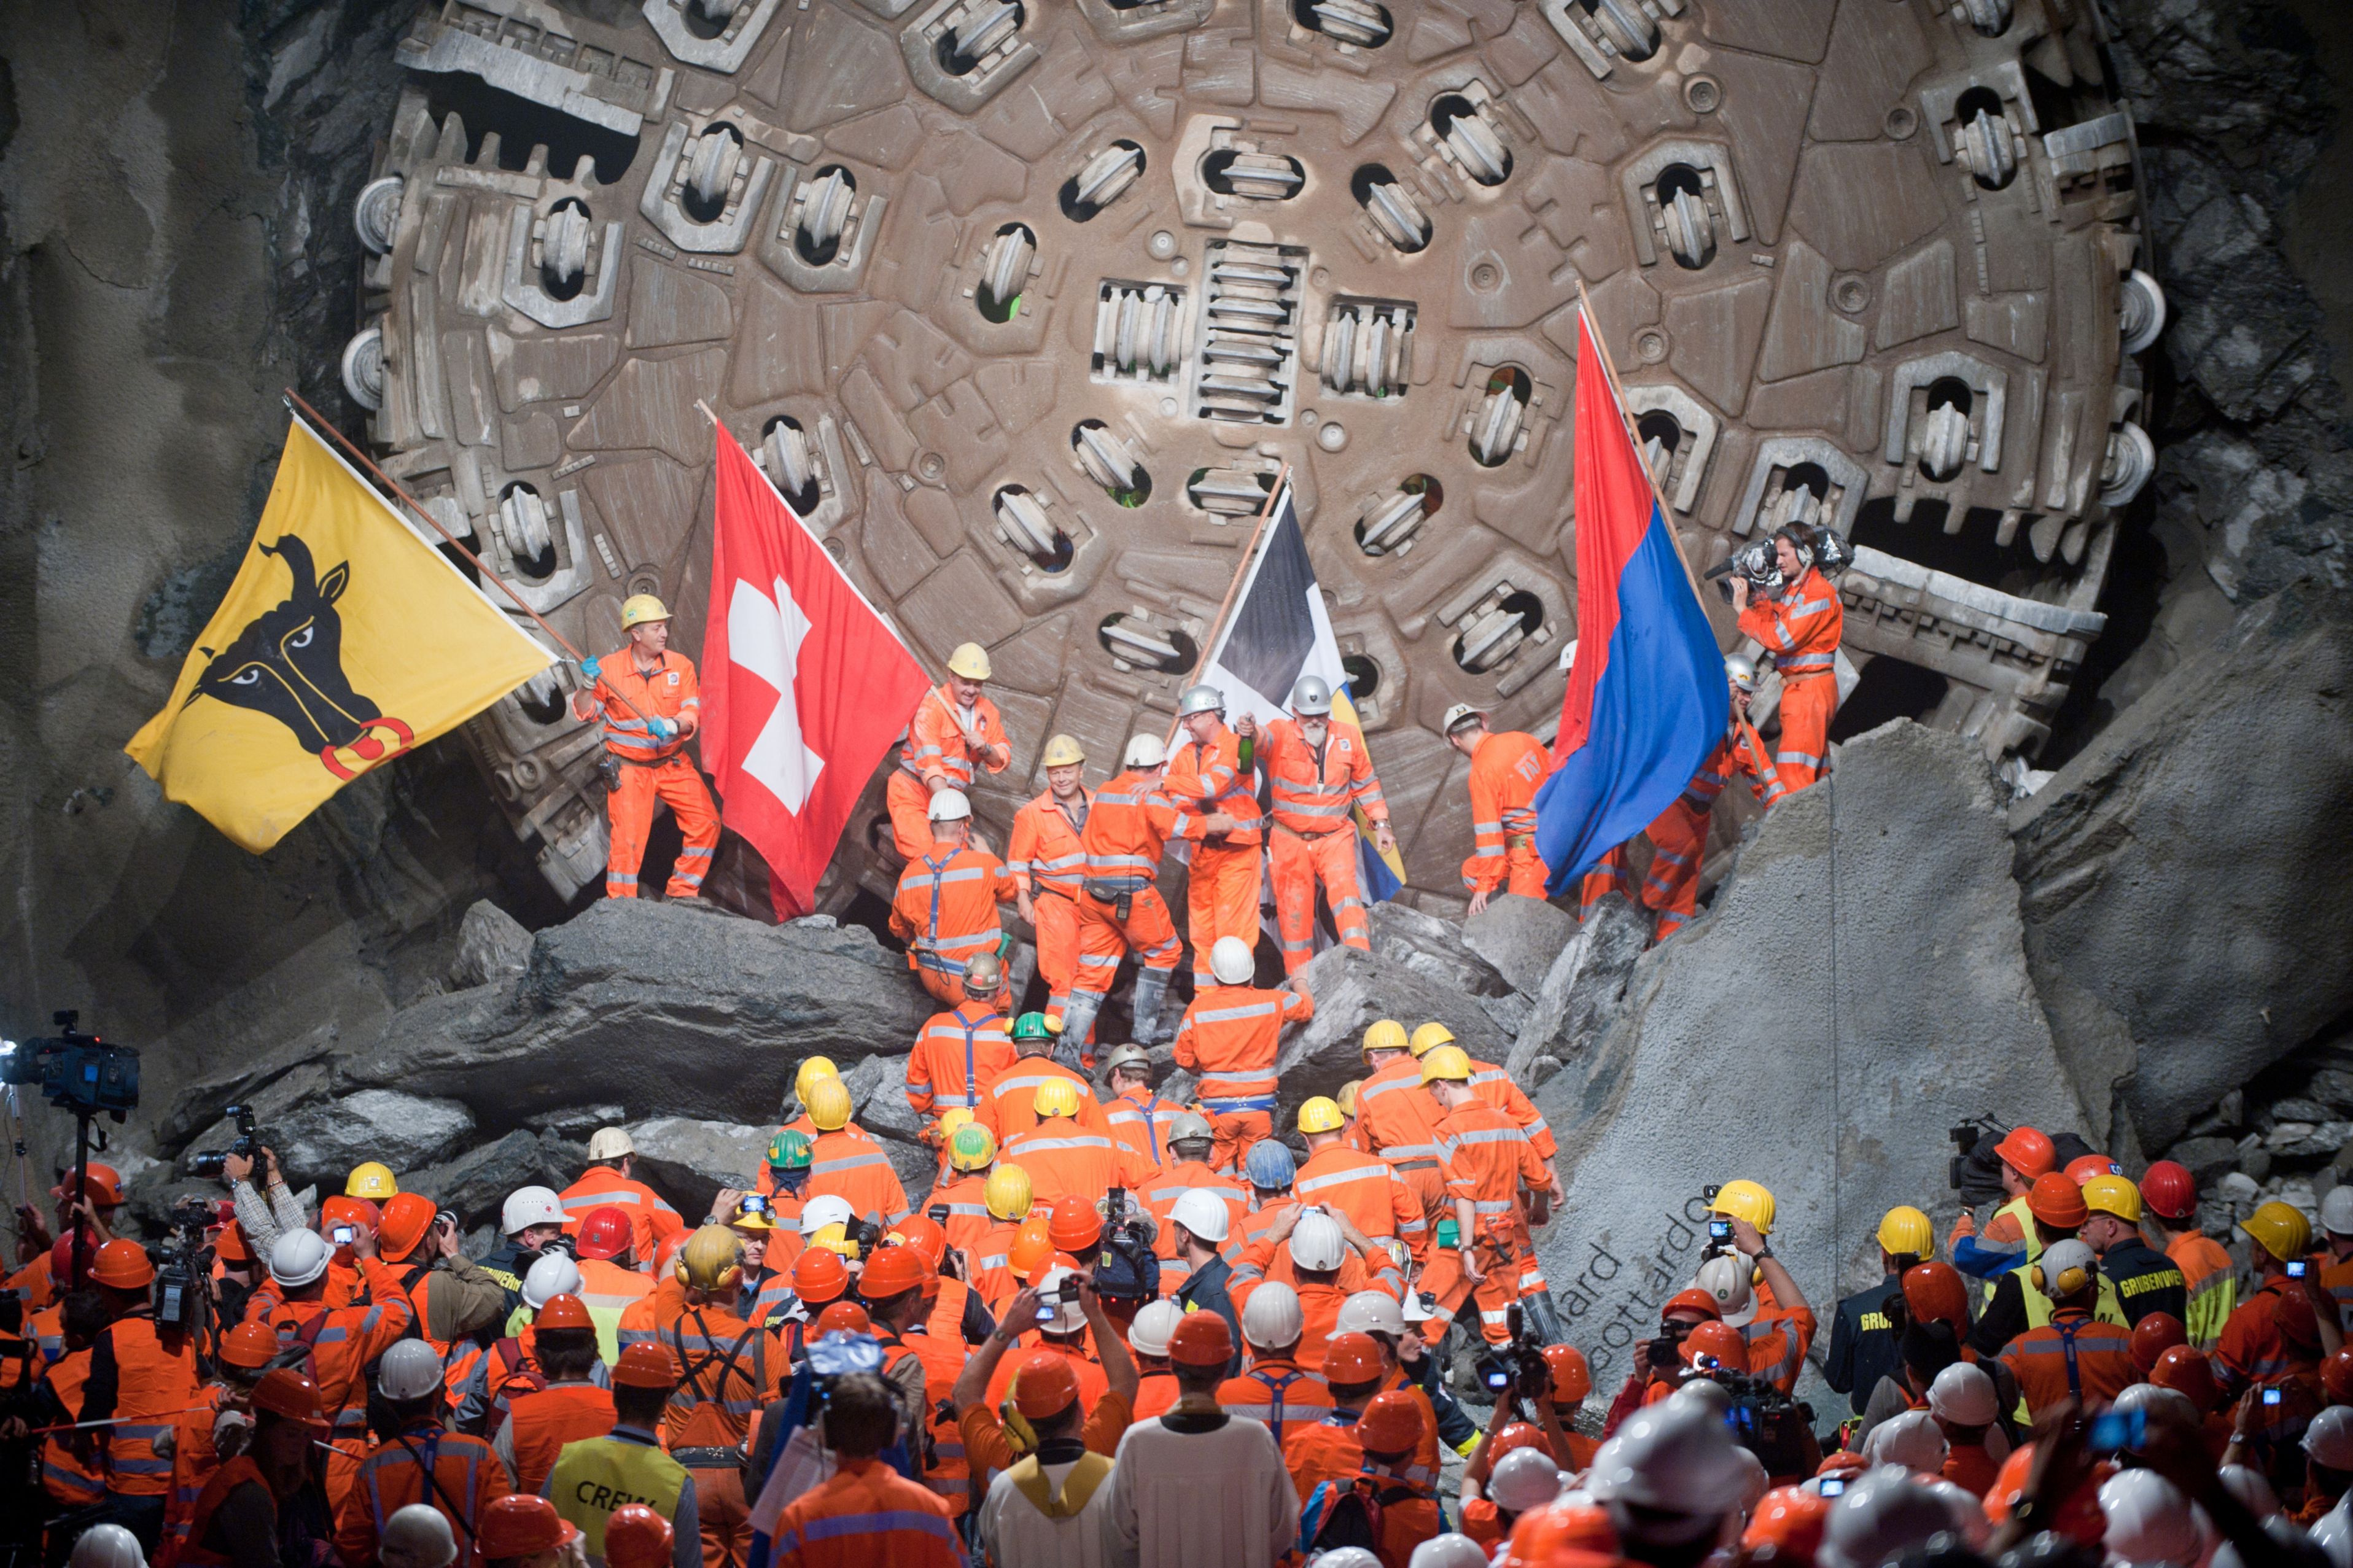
[1233,676,1398,975]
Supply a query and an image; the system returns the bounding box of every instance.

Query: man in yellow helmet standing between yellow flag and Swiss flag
[572,593,720,899]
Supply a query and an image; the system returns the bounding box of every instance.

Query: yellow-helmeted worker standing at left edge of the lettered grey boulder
[1422,1046,1550,1345]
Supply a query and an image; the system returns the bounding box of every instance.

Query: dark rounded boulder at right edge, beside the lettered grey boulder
[2012,584,2353,1149]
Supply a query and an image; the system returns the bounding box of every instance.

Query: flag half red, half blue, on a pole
[1536,316,1732,892]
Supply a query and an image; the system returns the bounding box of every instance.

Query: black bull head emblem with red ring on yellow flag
[189,535,414,779]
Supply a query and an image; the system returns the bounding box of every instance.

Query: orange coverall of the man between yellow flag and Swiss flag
[583,648,720,899]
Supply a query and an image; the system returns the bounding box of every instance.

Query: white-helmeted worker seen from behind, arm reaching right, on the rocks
[1059,734,1195,1050]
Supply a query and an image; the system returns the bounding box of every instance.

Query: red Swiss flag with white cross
[701,429,931,920]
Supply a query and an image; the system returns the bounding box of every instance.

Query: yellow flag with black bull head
[125,419,555,852]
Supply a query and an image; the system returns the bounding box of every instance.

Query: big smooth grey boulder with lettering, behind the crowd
[1536,720,2085,1408]
